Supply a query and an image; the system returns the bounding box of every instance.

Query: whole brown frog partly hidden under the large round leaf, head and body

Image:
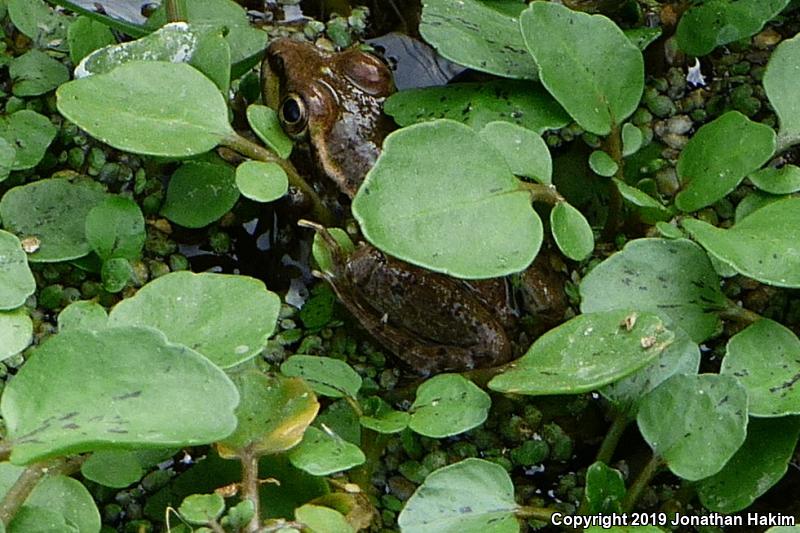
[263,39,567,374]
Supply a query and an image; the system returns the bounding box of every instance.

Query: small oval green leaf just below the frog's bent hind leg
[281,355,361,398]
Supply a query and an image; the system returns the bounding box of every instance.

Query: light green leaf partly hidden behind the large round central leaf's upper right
[480,121,553,185]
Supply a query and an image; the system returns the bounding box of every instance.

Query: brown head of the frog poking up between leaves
[262,38,394,198]
